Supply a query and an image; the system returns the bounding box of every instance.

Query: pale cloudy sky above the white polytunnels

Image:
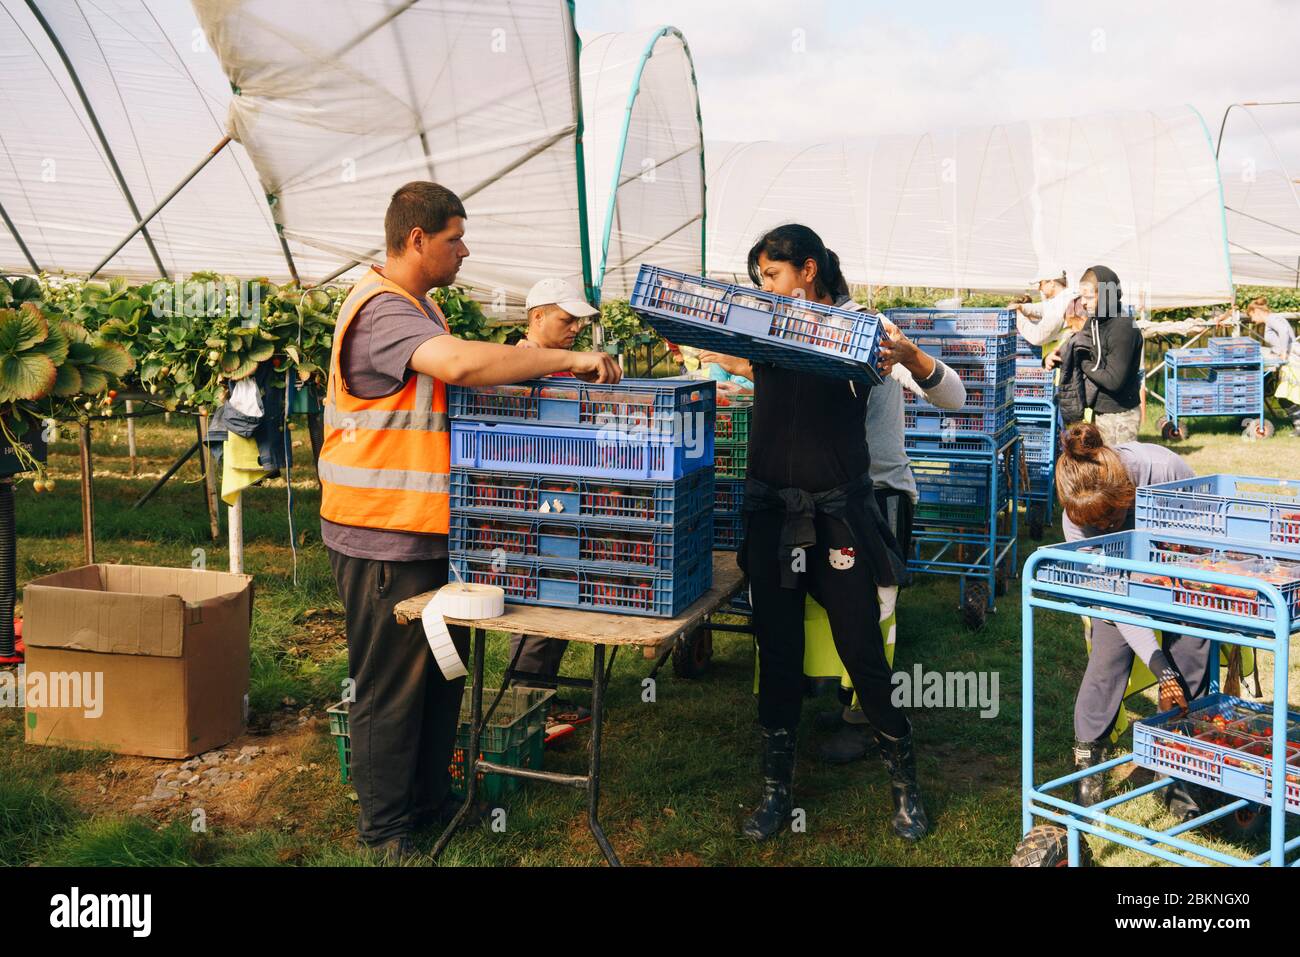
[576,0,1300,155]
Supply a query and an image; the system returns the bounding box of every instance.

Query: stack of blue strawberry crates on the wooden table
[449,378,715,616]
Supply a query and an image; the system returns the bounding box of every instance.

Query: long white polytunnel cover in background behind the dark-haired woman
[706,108,1231,307]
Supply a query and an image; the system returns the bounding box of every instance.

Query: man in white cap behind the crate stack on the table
[510,278,599,724]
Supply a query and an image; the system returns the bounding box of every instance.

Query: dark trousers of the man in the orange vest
[328,549,469,844]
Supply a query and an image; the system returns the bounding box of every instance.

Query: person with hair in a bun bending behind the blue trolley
[1056,423,1210,818]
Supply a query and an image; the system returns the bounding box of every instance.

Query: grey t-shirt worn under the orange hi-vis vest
[321,293,447,562]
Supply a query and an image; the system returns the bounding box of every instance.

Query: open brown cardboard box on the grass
[22,564,252,758]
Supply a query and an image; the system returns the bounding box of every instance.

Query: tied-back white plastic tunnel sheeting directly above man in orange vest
[194,0,586,317]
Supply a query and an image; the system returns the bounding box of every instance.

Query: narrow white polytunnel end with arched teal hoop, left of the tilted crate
[580,27,705,299]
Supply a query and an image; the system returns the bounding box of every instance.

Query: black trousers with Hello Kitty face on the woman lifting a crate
[745,510,909,737]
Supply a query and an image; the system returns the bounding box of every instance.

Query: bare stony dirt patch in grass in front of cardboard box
[62,719,337,828]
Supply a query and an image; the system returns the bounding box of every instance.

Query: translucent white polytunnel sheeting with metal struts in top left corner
[0,0,333,278]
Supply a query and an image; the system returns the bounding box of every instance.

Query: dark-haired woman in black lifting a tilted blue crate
[701,225,956,841]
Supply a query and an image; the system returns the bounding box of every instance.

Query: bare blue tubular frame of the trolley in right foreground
[1021,546,1300,867]
